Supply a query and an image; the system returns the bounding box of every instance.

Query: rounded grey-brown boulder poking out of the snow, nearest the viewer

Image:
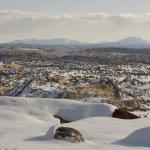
[54,127,84,143]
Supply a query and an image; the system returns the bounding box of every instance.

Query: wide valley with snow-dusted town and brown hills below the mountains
[0,45,150,109]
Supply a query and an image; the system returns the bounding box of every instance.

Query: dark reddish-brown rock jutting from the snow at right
[112,109,139,119]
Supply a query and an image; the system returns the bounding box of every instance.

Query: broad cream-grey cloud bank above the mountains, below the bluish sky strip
[0,10,150,42]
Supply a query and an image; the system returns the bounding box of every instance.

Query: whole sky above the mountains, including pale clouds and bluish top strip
[0,0,150,42]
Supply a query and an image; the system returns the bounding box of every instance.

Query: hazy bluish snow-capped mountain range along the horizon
[11,36,150,48]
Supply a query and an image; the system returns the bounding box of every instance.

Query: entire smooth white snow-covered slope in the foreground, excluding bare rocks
[0,97,150,150]
